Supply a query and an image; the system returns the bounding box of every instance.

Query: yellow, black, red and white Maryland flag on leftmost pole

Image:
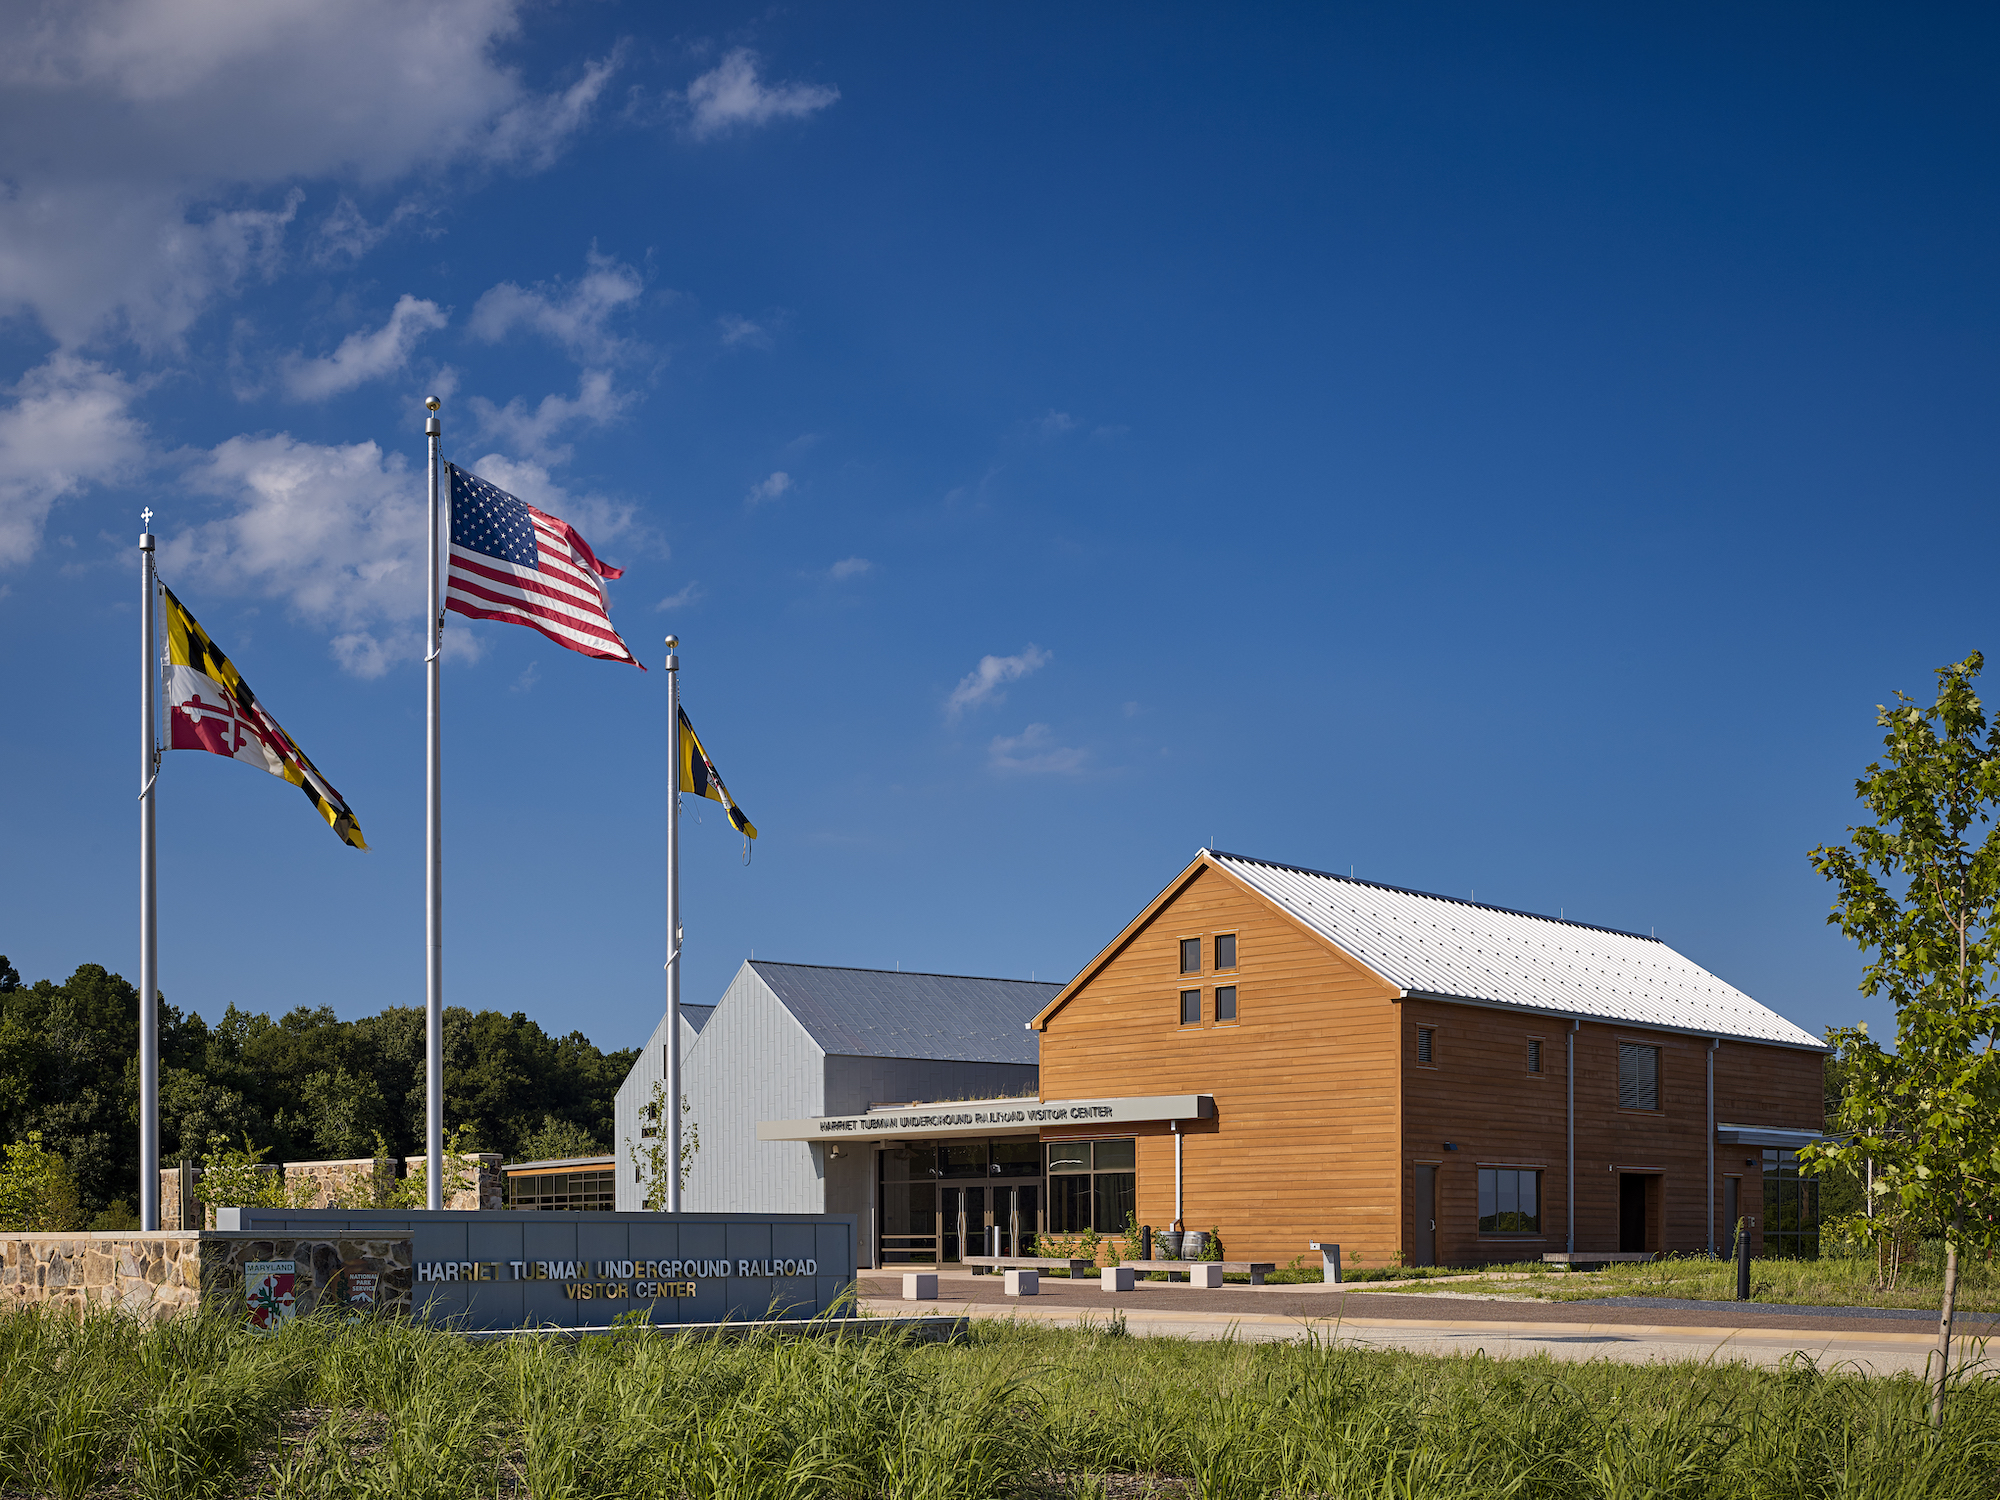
[160,584,368,848]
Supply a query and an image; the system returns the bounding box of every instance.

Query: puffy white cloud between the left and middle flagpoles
[160,432,434,678]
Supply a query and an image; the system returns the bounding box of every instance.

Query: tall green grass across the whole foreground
[0,1312,2000,1500]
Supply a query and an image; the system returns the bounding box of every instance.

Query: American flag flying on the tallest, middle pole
[444,464,646,672]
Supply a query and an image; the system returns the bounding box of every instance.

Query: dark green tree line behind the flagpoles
[0,954,638,1228]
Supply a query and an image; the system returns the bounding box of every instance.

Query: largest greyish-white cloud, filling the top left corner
[0,0,616,348]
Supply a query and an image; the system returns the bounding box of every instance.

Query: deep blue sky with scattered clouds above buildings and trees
[0,0,2000,1046]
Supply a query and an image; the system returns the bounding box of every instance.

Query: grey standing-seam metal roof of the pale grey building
[750,958,1062,1066]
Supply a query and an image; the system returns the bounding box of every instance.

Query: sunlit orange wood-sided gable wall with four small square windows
[1042,862,1402,1266]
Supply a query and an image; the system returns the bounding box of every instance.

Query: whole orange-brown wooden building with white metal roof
[1032,850,1824,1266]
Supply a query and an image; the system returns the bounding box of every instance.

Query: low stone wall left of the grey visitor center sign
[0,1230,414,1320]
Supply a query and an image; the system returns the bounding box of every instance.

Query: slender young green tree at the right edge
[1802,652,2000,1426]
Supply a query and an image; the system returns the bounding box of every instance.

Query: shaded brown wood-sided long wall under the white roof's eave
[1400,998,1822,1266]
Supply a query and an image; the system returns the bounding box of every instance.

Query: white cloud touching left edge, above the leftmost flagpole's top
[0,354,146,568]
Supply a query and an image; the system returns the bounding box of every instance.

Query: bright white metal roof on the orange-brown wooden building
[1210,850,1824,1050]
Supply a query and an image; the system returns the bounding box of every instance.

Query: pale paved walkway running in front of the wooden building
[860,1272,2000,1374]
